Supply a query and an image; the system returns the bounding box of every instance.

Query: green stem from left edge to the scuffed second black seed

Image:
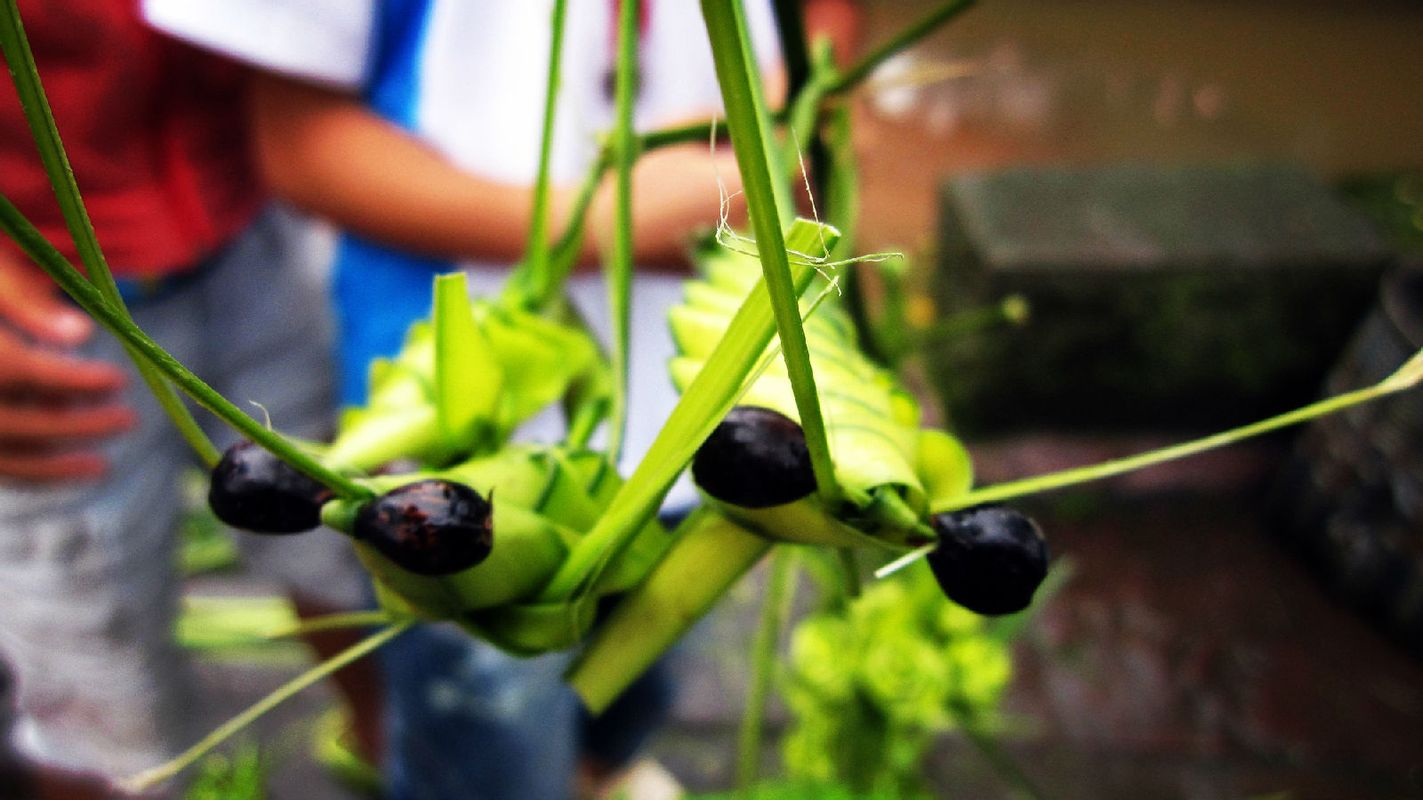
[0,195,371,500]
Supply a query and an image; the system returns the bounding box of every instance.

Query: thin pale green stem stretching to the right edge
[933,350,1423,512]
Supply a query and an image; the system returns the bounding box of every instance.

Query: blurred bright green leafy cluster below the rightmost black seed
[781,562,1062,797]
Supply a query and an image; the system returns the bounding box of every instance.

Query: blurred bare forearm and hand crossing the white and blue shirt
[252,73,737,269]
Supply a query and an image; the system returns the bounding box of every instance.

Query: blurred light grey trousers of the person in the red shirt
[0,211,364,776]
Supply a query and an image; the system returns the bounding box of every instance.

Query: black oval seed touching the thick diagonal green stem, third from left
[692,406,815,508]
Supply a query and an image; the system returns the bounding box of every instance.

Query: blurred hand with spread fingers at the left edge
[0,252,134,481]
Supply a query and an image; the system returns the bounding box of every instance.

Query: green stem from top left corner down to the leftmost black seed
[0,0,222,467]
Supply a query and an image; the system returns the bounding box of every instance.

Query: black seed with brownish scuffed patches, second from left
[354,478,494,575]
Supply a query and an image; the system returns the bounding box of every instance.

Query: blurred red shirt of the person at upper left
[0,0,262,276]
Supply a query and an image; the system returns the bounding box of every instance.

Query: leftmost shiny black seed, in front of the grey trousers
[208,441,332,534]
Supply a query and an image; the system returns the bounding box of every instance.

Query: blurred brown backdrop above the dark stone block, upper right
[859,0,1423,246]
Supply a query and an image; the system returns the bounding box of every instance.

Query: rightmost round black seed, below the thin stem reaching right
[928,505,1047,615]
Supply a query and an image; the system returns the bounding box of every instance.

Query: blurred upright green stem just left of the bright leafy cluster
[736,547,795,793]
